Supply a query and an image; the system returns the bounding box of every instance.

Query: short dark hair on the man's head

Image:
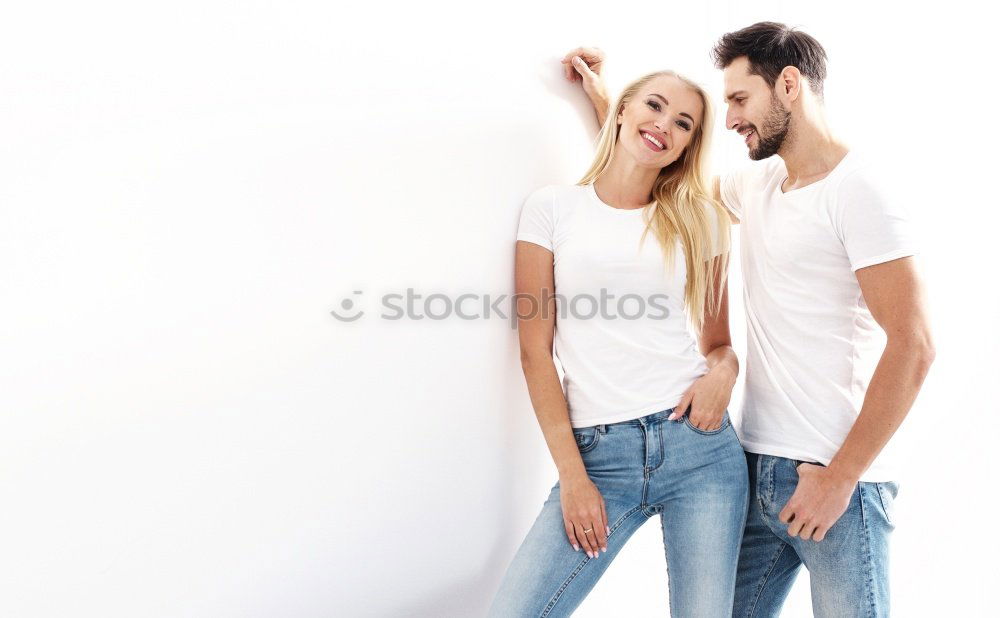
[712,21,826,99]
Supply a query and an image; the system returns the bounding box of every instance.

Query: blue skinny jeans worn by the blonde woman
[489,409,749,618]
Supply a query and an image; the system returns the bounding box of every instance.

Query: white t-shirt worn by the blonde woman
[517,184,728,427]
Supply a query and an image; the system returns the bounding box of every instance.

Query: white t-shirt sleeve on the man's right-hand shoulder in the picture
[834,172,918,270]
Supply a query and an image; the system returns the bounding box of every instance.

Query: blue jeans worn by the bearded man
[733,453,898,618]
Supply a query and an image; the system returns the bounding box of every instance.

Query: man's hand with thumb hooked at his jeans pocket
[778,463,857,541]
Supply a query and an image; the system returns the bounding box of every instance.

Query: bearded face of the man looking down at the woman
[723,56,792,161]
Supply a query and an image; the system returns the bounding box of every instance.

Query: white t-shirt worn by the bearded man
[721,151,916,481]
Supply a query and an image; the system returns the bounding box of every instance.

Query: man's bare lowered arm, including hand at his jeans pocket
[778,257,934,541]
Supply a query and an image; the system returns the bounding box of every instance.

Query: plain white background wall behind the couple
[0,0,1000,618]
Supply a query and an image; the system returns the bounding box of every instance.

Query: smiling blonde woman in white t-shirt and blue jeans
[490,63,747,618]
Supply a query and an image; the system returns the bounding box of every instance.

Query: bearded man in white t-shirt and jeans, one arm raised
[563,22,934,618]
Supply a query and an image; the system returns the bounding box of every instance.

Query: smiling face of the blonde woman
[617,75,703,169]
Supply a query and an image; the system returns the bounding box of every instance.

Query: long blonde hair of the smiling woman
[577,71,730,332]
